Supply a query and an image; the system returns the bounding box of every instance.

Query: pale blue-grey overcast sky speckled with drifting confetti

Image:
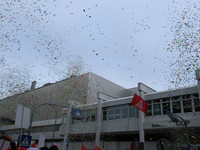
[0,0,200,91]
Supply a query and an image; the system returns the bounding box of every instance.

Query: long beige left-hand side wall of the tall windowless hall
[0,73,89,121]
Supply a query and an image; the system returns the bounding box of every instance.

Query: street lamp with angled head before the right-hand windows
[167,111,190,150]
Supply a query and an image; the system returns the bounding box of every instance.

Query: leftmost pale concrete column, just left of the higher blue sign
[62,107,71,150]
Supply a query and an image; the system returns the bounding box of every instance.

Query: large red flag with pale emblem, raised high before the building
[131,94,149,113]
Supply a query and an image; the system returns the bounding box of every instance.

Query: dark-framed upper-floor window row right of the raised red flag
[146,93,200,116]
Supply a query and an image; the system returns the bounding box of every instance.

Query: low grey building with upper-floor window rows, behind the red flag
[60,86,200,150]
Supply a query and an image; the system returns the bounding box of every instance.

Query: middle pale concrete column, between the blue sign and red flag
[95,99,102,147]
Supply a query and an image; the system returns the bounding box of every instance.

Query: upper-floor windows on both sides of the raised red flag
[103,93,200,120]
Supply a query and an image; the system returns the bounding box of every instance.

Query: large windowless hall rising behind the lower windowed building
[0,72,135,146]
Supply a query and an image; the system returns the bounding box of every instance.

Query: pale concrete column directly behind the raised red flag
[139,90,144,150]
